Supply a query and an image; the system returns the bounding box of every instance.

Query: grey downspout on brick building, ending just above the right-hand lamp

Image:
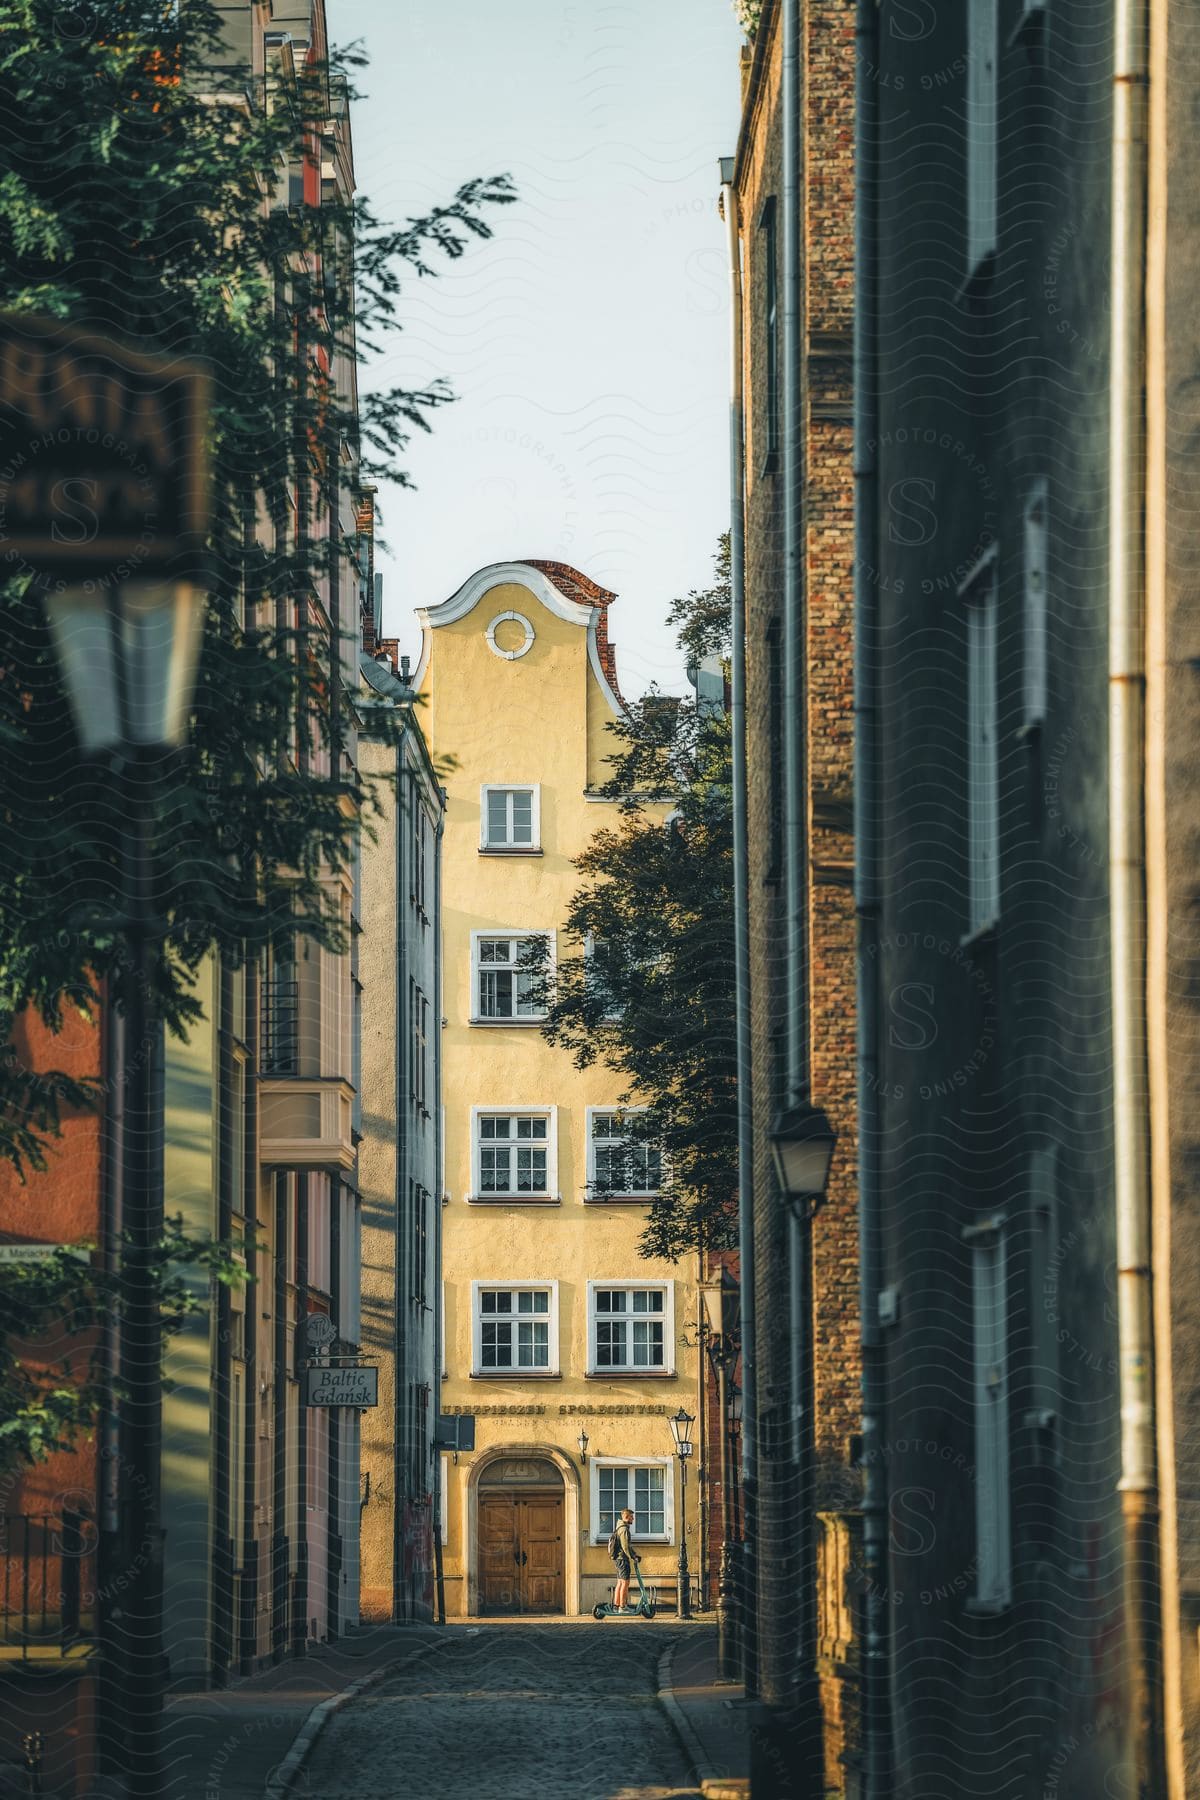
[779,0,808,1107]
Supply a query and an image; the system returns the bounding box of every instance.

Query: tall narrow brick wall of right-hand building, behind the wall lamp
[736,0,860,1793]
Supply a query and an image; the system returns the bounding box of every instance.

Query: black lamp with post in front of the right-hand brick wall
[766,1102,837,1800]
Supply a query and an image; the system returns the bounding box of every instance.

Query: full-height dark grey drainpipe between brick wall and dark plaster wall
[855,0,892,1800]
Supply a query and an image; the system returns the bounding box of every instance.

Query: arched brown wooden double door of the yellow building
[475,1453,567,1616]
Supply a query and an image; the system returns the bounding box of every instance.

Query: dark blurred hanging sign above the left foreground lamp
[0,313,209,583]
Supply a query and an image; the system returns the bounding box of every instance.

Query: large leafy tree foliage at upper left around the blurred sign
[0,0,515,1175]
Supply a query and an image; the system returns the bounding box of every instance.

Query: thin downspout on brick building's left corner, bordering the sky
[721,157,757,1699]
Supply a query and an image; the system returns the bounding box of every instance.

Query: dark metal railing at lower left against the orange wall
[0,1512,97,1660]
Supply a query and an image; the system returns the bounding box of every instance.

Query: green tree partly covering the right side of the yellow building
[540,538,738,1258]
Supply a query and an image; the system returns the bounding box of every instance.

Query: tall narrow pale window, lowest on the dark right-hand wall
[963,1213,1013,1613]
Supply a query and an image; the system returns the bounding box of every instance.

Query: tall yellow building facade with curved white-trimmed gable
[416,562,698,1616]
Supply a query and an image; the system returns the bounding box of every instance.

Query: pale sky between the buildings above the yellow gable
[329,0,739,695]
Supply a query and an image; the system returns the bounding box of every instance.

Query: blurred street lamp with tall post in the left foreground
[45,580,203,1800]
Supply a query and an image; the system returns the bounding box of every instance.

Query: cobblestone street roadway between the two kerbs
[295,1624,698,1800]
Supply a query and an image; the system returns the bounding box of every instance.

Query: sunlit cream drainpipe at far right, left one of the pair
[1108,0,1164,1800]
